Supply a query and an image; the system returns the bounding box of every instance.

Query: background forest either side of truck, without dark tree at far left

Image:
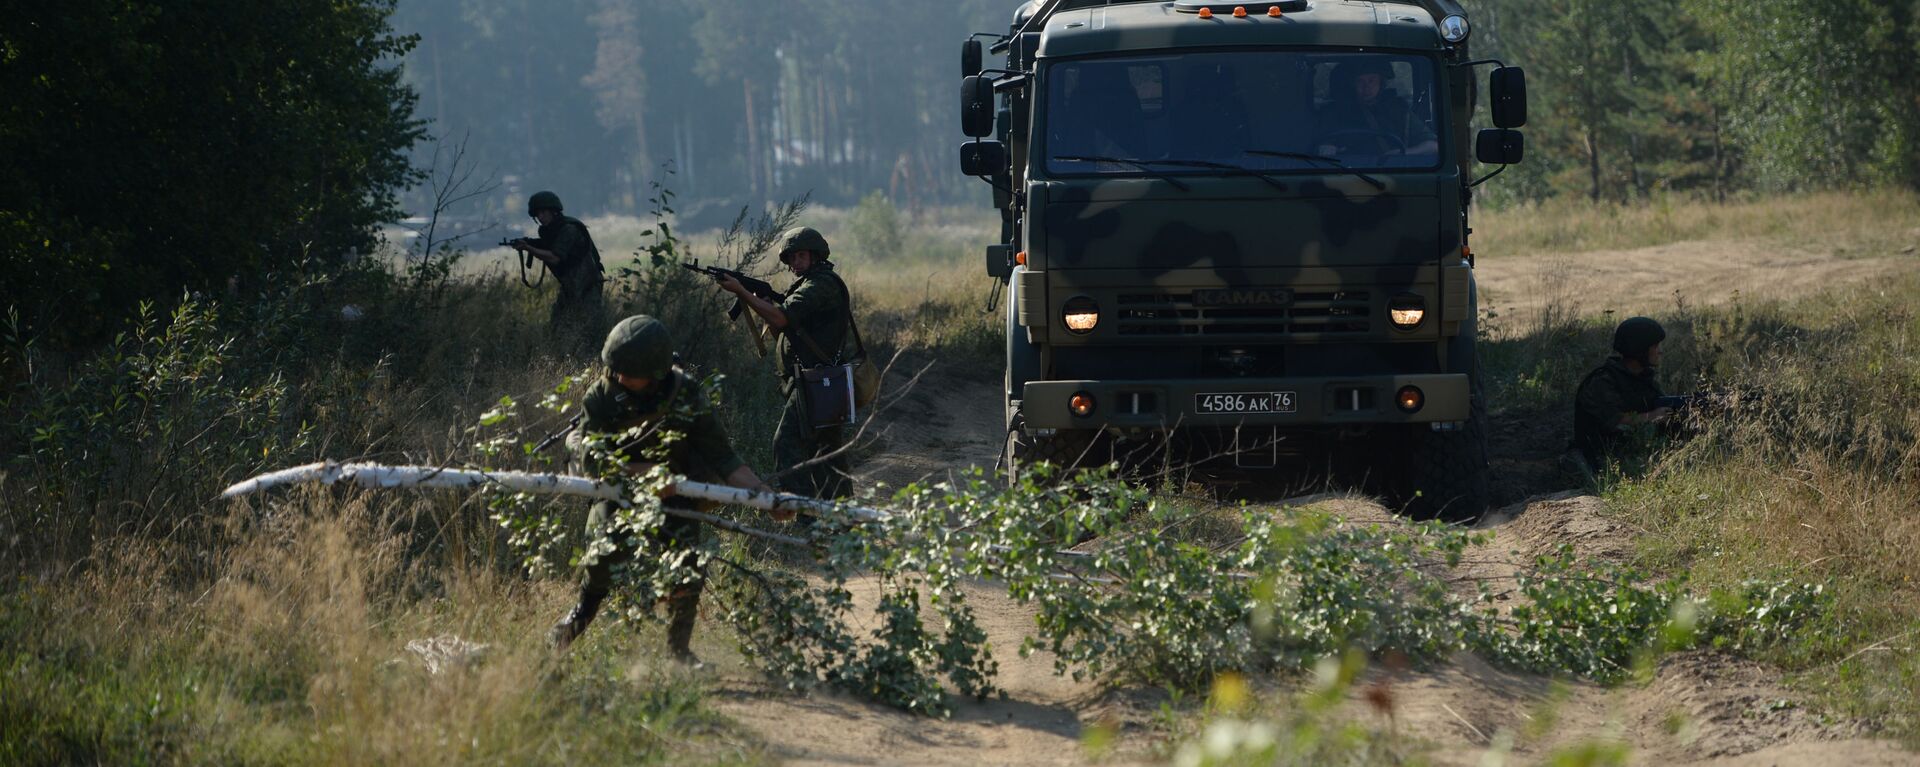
[396,0,1920,223]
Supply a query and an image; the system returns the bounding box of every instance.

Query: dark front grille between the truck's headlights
[1117,290,1373,336]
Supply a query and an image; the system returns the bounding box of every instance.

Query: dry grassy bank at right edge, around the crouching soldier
[1484,257,1920,740]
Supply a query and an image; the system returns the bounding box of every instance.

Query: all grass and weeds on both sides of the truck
[0,194,1920,763]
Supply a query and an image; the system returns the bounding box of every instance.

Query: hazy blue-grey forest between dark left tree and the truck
[396,0,1018,223]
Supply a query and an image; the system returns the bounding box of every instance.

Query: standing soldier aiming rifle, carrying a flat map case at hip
[720,227,852,498]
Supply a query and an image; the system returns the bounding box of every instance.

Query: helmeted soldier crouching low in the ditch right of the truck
[1569,317,1672,477]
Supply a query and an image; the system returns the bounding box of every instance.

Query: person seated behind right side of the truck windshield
[1319,58,1440,158]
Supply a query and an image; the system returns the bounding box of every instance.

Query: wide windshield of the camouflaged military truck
[1044,52,1440,175]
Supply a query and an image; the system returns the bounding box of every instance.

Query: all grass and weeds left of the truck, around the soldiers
[0,194,998,765]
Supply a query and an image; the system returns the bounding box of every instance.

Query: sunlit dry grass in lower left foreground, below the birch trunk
[0,492,760,765]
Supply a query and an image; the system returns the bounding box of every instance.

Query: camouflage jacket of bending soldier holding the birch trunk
[570,367,745,482]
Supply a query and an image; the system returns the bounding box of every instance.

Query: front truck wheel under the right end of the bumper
[1407,365,1490,523]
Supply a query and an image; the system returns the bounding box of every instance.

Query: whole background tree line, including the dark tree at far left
[0,0,1920,338]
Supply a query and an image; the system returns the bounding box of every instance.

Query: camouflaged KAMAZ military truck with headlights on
[960,0,1526,519]
